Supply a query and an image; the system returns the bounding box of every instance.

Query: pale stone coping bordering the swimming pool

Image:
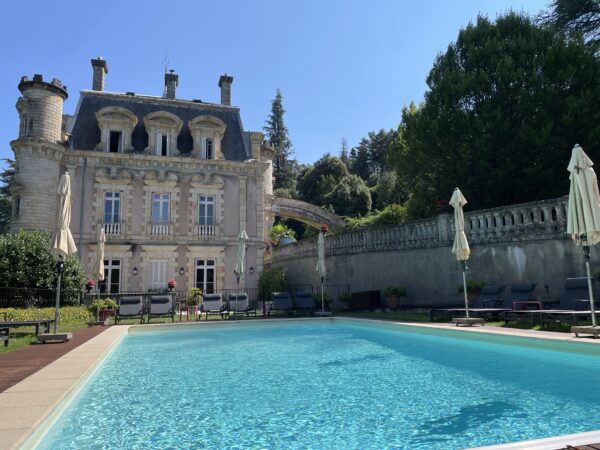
[0,316,600,450]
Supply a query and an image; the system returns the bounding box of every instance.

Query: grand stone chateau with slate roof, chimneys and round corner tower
[11,58,274,292]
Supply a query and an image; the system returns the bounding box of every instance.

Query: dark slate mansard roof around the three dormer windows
[71,91,251,161]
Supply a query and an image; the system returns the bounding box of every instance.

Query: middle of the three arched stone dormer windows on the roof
[144,111,183,156]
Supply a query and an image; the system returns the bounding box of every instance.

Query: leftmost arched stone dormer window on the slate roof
[96,106,137,153]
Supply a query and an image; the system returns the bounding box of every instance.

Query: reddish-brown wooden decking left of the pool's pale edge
[0,327,105,392]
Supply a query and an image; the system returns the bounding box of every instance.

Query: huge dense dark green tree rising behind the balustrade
[388,12,600,218]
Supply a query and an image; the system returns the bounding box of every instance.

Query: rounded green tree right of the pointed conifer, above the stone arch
[298,153,348,206]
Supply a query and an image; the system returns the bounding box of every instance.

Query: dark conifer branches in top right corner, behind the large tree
[540,0,600,52]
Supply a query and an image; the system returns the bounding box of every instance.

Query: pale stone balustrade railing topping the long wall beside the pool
[272,196,568,262]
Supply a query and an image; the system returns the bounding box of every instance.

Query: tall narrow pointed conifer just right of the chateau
[263,89,298,191]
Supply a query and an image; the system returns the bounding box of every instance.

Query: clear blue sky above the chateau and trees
[0,0,548,171]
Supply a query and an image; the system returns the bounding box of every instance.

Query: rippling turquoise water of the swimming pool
[38,321,600,450]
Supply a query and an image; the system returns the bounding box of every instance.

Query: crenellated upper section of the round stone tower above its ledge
[16,75,68,142]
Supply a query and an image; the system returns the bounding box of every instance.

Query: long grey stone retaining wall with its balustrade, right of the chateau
[271,197,600,306]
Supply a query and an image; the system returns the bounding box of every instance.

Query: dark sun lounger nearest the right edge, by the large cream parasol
[504,277,592,325]
